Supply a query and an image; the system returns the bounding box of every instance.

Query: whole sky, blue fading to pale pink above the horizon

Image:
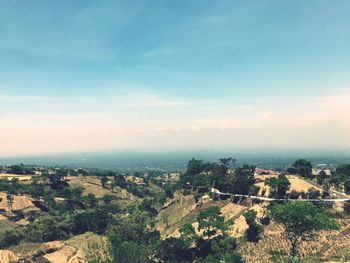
[0,0,350,156]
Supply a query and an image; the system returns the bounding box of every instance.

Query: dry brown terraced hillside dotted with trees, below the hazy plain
[0,159,350,263]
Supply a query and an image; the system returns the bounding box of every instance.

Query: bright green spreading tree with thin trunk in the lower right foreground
[268,202,339,257]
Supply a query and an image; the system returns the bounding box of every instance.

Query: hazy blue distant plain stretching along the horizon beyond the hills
[0,149,350,171]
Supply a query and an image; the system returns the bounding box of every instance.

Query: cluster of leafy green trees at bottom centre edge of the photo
[108,206,243,263]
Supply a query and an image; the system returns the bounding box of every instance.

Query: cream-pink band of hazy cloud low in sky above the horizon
[0,91,350,155]
